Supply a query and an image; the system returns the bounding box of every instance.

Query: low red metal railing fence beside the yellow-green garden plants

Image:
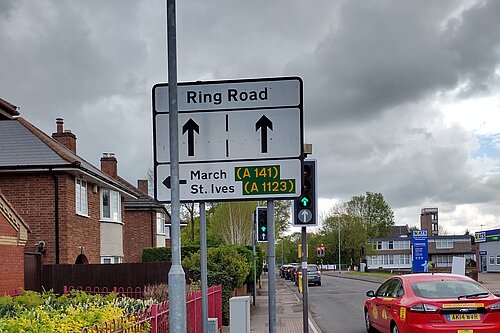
[64,285,222,333]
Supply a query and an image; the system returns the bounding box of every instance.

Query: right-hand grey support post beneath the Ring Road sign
[267,200,276,333]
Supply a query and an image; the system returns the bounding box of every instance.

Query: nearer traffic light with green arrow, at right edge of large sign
[294,160,318,227]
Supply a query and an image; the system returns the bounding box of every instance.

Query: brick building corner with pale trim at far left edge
[0,192,29,296]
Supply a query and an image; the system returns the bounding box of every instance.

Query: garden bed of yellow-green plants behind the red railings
[0,291,154,333]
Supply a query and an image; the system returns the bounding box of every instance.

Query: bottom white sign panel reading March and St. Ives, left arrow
[156,160,302,202]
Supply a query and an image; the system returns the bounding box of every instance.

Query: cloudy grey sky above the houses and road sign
[0,0,500,234]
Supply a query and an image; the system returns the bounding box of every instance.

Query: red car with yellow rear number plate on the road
[364,273,500,333]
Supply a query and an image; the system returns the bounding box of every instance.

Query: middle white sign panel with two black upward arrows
[156,108,301,163]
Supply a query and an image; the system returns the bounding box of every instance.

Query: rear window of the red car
[411,280,489,299]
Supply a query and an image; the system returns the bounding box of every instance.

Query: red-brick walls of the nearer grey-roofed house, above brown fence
[0,173,100,264]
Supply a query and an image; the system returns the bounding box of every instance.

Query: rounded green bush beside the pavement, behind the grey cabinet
[182,245,253,325]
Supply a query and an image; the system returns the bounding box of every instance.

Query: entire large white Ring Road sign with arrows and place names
[153,77,303,203]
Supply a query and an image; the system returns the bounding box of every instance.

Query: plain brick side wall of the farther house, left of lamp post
[123,210,156,263]
